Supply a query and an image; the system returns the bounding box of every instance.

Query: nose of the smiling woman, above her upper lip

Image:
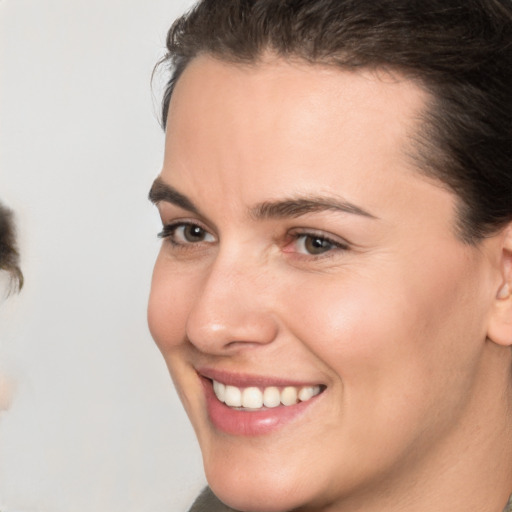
[186,255,278,355]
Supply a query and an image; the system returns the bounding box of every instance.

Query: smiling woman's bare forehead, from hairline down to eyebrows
[162,56,450,228]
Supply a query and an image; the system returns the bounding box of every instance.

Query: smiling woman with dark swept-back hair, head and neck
[148,0,512,512]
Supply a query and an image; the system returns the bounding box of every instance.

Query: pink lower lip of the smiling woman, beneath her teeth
[201,378,320,436]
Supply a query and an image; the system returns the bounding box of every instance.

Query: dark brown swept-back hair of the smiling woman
[157,0,512,243]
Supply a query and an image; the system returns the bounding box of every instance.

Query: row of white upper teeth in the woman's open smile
[213,380,320,409]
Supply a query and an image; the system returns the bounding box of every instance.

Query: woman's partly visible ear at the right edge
[487,223,512,346]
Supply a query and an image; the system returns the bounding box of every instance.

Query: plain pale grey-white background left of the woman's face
[0,0,204,512]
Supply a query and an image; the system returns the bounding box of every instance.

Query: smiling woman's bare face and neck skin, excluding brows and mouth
[148,56,512,512]
